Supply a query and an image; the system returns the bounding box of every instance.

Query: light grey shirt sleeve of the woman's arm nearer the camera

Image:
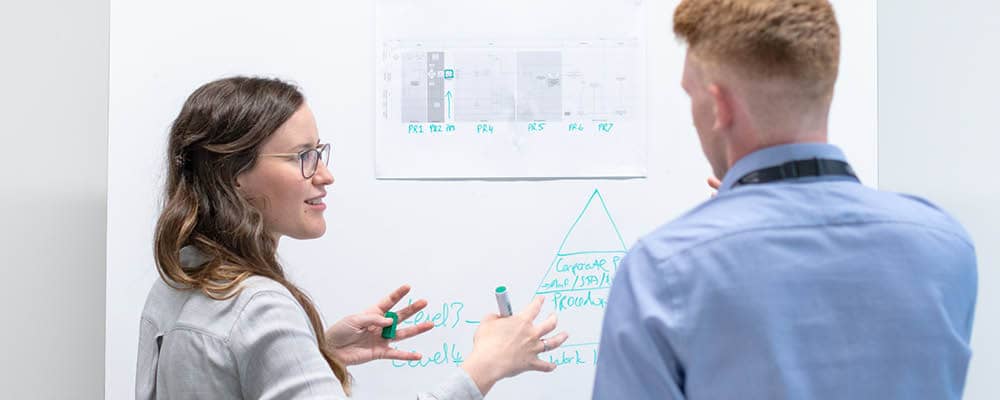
[230,291,483,400]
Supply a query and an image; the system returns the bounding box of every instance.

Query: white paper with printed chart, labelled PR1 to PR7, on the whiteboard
[375,1,646,179]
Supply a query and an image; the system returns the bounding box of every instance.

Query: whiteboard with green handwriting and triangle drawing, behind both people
[105,0,877,399]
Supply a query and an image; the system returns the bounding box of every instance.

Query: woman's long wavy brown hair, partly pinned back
[154,77,351,395]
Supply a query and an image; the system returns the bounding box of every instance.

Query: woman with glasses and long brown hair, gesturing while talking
[136,77,567,399]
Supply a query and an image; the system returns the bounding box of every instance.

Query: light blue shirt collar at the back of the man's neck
[719,143,847,193]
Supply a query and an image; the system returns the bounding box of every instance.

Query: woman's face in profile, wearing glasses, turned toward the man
[236,104,333,239]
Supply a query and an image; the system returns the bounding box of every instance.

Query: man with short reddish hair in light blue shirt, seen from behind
[594,0,977,400]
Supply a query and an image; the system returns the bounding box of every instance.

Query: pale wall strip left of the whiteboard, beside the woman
[0,0,109,399]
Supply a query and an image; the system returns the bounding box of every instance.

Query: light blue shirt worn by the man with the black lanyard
[594,144,977,400]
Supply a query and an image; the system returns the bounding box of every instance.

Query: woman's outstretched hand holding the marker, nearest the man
[462,296,569,395]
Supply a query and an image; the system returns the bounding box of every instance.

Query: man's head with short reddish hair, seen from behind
[674,0,840,178]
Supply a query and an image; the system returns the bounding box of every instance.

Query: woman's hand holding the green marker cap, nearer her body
[326,285,434,365]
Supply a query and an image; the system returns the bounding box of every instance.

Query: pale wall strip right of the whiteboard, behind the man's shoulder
[878,0,1000,400]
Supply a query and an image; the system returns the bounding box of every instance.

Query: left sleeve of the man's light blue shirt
[593,242,685,400]
